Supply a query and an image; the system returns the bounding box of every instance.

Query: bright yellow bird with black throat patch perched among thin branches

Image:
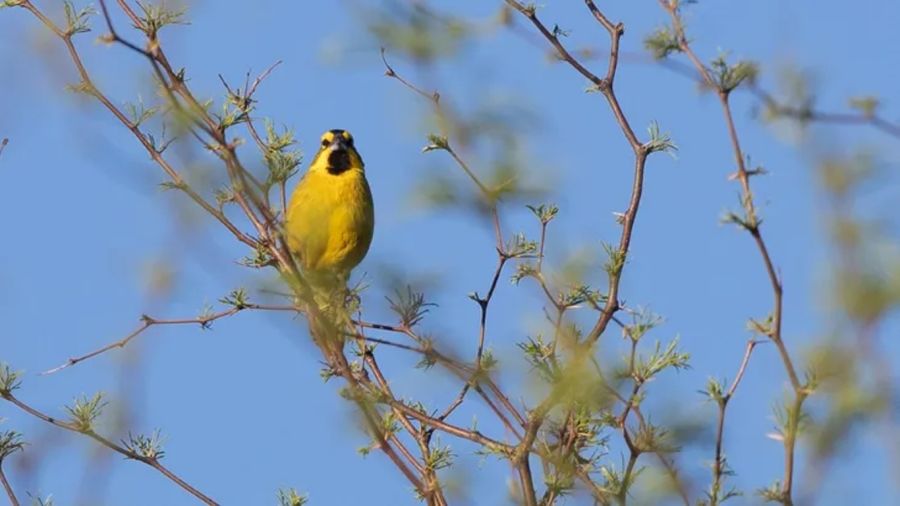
[284,130,375,282]
